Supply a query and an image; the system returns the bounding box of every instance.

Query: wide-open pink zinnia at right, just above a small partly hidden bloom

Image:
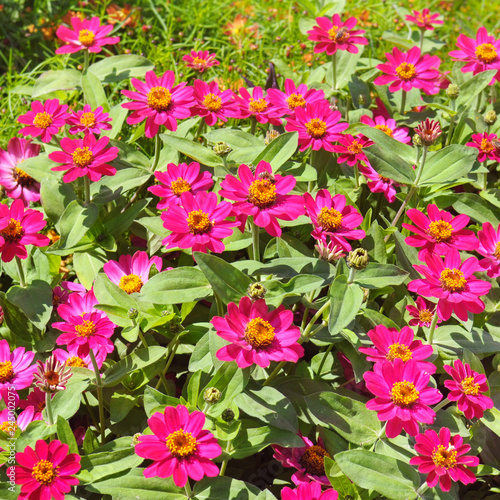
[408,248,491,321]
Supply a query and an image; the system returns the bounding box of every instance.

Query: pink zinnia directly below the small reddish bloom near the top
[191,80,239,126]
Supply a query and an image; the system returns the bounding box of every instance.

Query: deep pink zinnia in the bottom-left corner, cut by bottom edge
[15,439,81,500]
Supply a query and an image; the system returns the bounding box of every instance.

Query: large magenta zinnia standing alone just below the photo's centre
[211,296,304,368]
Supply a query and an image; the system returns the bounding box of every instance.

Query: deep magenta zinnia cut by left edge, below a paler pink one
[0,200,50,262]
